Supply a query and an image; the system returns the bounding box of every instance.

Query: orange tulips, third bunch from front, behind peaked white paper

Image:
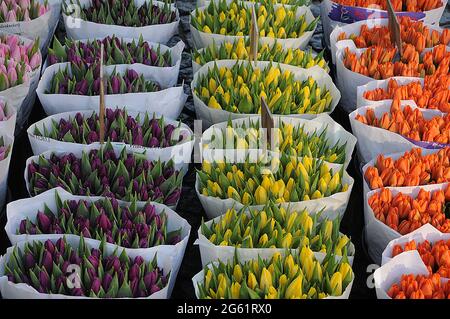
[368,187,450,235]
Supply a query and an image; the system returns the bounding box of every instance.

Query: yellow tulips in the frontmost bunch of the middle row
[193,247,354,299]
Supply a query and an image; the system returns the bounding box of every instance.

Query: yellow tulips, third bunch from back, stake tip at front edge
[194,61,333,115]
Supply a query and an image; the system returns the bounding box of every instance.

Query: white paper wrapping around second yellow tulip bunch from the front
[194,211,355,267]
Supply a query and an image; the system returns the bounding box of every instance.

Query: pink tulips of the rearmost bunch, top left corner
[0,0,50,23]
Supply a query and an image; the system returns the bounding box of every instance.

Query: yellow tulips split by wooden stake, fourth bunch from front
[205,120,346,164]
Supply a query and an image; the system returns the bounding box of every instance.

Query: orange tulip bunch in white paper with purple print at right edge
[349,100,450,162]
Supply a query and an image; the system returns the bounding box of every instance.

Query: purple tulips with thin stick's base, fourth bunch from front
[33,108,185,147]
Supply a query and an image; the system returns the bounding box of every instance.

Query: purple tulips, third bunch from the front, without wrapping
[26,143,183,206]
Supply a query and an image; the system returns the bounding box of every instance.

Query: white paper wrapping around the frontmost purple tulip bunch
[0,237,176,299]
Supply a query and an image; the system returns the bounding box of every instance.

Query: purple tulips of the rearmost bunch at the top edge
[63,0,177,27]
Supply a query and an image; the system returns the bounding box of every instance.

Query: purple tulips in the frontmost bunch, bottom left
[4,237,170,298]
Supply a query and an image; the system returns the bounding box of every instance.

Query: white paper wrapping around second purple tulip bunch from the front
[5,187,191,295]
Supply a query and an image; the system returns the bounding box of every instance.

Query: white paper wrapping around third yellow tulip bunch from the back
[191,60,341,129]
